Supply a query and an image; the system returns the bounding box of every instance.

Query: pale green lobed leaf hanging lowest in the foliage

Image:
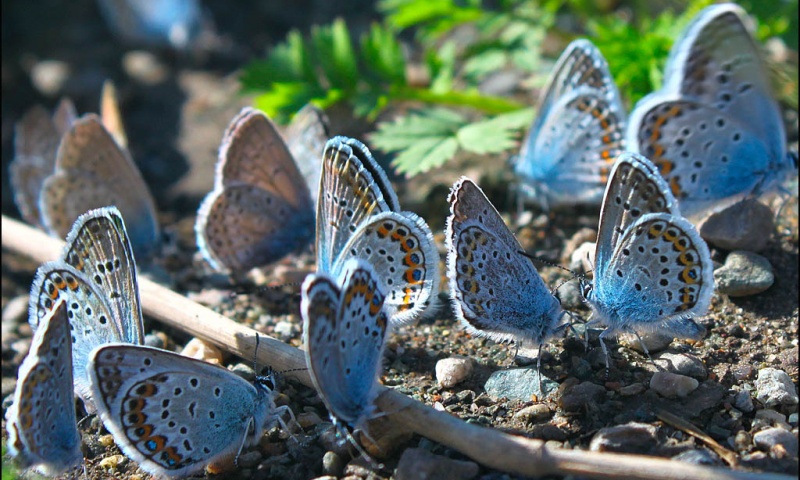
[370,108,533,176]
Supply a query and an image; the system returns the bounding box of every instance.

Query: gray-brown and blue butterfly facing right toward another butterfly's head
[445,177,567,374]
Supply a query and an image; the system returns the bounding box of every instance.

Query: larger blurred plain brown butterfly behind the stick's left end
[39,115,159,259]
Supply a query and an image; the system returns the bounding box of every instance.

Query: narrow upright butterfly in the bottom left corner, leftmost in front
[6,300,83,475]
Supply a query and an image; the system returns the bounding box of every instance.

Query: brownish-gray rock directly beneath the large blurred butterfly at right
[698,199,775,252]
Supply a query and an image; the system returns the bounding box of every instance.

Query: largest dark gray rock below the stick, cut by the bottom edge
[395,448,478,480]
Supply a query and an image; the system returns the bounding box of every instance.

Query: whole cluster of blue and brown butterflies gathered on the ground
[7,4,791,477]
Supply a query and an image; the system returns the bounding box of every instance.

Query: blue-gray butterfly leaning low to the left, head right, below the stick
[86,344,288,478]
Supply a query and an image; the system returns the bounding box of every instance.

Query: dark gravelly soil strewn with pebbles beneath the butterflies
[2,1,798,479]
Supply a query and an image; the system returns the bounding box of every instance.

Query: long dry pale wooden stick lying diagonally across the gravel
[2,216,794,480]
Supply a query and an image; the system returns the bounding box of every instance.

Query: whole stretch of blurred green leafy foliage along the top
[241,0,798,176]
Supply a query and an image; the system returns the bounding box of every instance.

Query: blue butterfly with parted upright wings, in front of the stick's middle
[300,258,388,445]
